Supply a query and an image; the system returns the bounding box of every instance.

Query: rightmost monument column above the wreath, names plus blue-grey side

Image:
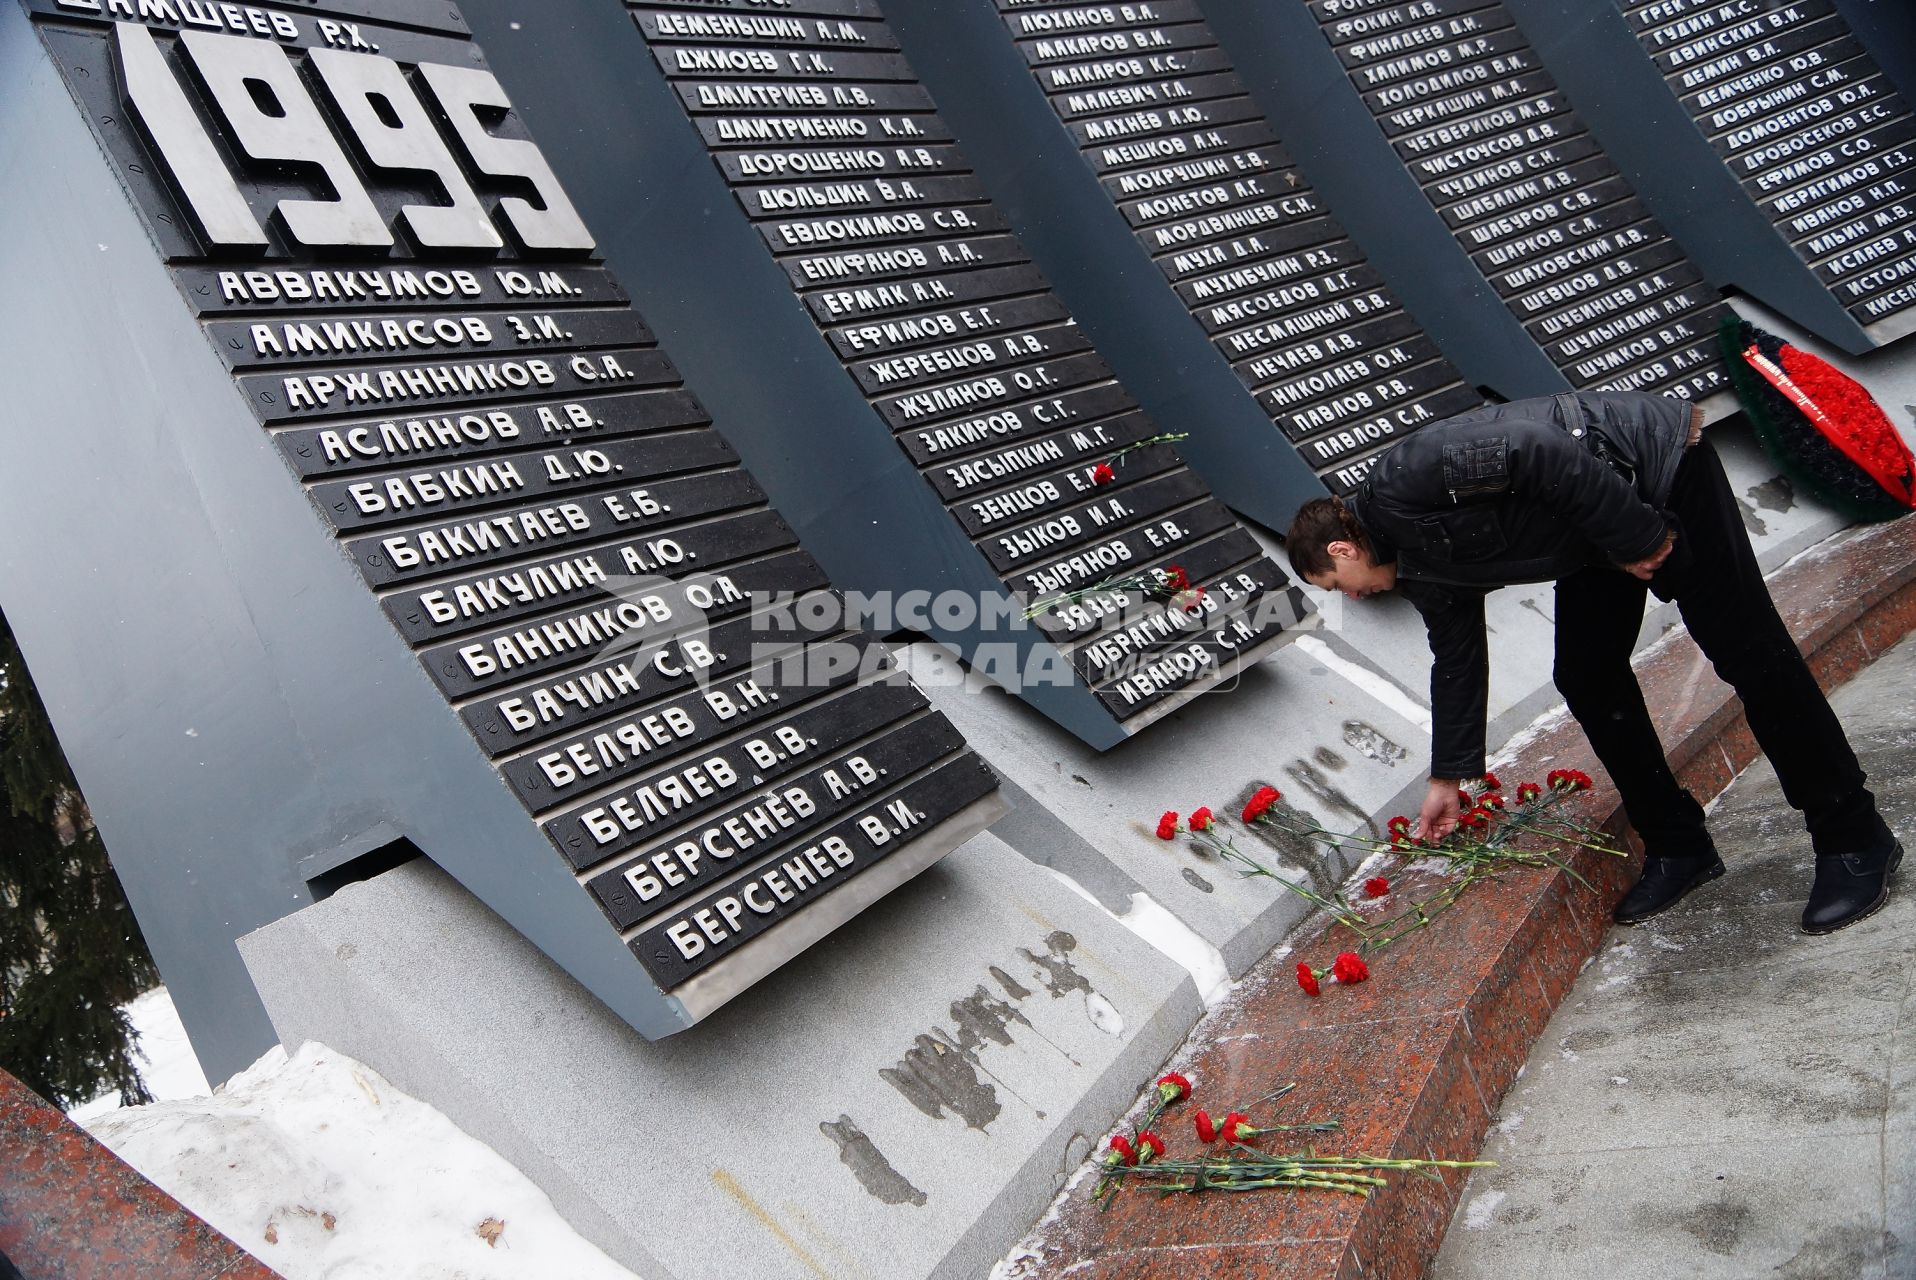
[1510,0,1916,354]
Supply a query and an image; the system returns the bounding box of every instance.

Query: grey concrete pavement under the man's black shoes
[1429,636,1916,1280]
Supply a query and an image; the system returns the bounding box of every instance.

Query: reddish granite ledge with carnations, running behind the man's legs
[1017,519,1916,1280]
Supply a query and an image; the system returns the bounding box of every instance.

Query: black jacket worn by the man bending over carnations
[1351,391,1690,778]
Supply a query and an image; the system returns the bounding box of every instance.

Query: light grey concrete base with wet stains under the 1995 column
[240,835,1201,1280]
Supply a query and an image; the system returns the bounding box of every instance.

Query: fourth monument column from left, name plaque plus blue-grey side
[1203,0,1734,416]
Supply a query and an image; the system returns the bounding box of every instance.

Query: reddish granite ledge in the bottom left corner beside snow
[0,1071,278,1280]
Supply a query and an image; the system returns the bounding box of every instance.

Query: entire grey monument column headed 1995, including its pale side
[0,0,1004,1079]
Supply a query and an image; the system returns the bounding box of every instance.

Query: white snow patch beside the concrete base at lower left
[73,991,634,1280]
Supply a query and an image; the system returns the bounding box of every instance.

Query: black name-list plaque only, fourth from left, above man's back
[1286,0,1739,399]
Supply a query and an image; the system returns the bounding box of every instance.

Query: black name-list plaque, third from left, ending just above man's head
[996,0,1479,494]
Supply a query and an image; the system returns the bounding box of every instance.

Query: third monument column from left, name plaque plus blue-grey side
[887,0,1483,529]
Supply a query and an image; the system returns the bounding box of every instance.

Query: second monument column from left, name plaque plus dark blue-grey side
[459,0,1309,749]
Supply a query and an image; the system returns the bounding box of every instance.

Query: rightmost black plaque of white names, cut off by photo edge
[1621,0,1916,341]
